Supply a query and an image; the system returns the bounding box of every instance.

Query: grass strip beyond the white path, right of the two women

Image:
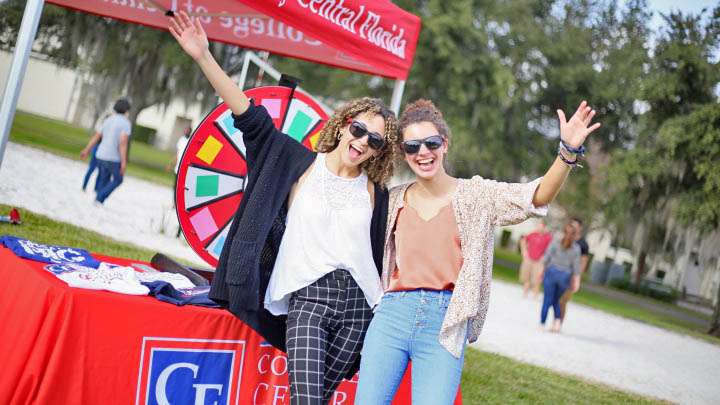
[493,249,720,344]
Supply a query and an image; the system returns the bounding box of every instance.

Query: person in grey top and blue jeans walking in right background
[540,223,580,332]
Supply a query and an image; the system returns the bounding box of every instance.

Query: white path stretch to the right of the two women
[472,281,720,404]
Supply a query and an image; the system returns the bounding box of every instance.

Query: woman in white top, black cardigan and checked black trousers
[170,12,399,404]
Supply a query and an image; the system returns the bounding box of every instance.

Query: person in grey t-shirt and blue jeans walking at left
[80,99,131,204]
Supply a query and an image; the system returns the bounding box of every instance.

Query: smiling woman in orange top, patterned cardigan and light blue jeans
[355,100,600,404]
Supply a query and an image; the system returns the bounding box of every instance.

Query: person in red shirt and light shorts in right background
[520,220,552,299]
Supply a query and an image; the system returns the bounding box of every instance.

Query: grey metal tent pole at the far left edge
[0,0,45,167]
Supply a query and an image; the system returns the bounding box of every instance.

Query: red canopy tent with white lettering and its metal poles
[0,0,420,165]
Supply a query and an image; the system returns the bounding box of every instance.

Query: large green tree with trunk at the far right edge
[605,7,720,283]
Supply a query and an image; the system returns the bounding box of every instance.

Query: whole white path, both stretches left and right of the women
[5,143,720,404]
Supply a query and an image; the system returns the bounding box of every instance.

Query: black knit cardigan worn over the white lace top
[210,102,388,376]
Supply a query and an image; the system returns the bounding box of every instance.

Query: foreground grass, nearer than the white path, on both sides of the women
[0,204,661,404]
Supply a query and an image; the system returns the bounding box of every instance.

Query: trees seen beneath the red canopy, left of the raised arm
[0,0,224,137]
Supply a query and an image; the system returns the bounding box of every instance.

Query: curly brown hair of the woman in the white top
[315,97,400,187]
